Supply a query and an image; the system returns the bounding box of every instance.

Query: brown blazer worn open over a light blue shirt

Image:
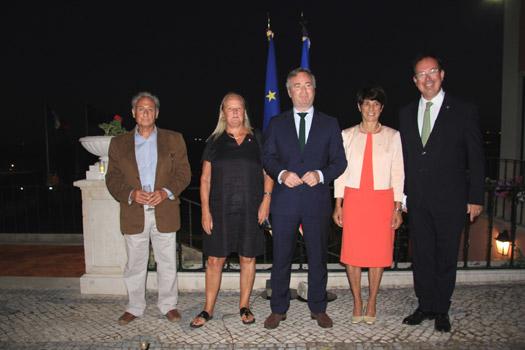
[106,128,191,234]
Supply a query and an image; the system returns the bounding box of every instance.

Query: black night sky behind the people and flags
[0,0,503,180]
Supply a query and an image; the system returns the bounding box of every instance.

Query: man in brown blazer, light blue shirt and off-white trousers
[106,92,191,325]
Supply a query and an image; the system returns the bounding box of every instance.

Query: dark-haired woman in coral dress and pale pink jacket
[333,87,404,324]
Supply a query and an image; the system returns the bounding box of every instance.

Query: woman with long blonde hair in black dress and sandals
[190,93,273,328]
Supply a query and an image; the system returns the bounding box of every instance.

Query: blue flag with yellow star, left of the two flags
[263,30,281,130]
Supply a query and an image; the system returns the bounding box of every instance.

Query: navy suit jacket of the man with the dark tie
[263,110,346,216]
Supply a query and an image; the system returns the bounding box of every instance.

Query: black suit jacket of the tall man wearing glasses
[399,94,485,212]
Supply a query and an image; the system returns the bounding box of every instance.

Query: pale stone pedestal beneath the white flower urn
[74,180,127,295]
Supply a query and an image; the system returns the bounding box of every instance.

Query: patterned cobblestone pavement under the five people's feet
[0,284,525,350]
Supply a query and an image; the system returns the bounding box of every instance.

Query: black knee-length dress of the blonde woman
[202,131,264,257]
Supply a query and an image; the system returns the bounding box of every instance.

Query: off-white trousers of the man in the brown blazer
[124,210,178,317]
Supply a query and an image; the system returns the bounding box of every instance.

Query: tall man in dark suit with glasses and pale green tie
[399,56,484,332]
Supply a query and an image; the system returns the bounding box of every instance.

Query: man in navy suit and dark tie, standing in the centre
[263,68,346,329]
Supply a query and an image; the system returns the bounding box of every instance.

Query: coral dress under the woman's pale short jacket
[341,133,395,267]
